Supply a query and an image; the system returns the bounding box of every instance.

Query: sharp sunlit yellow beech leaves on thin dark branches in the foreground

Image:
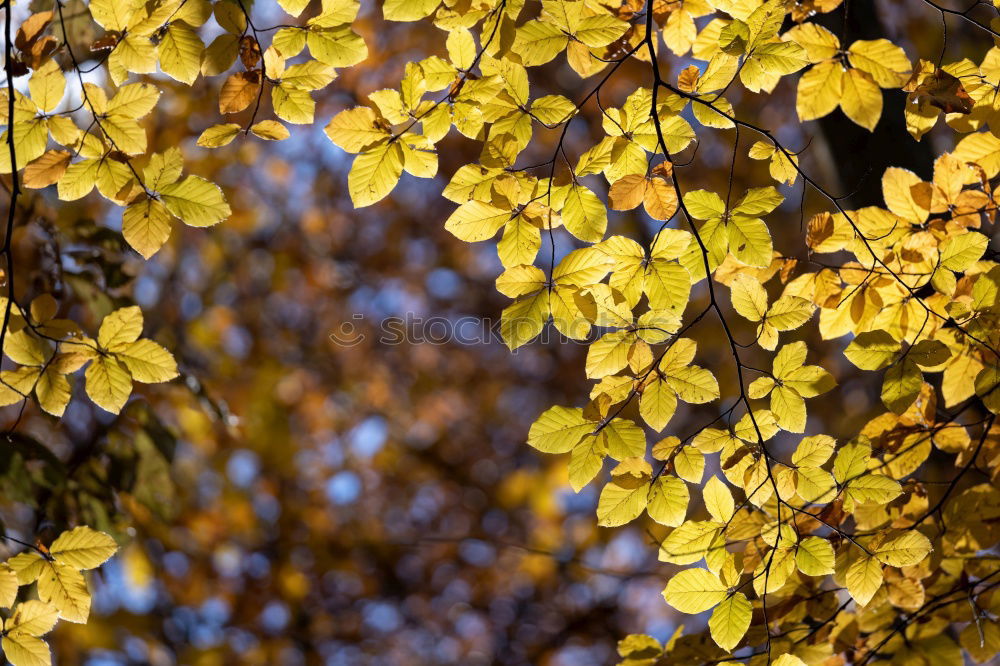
[0,0,1000,666]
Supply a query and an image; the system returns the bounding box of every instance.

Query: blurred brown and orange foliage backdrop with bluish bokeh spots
[0,0,983,666]
